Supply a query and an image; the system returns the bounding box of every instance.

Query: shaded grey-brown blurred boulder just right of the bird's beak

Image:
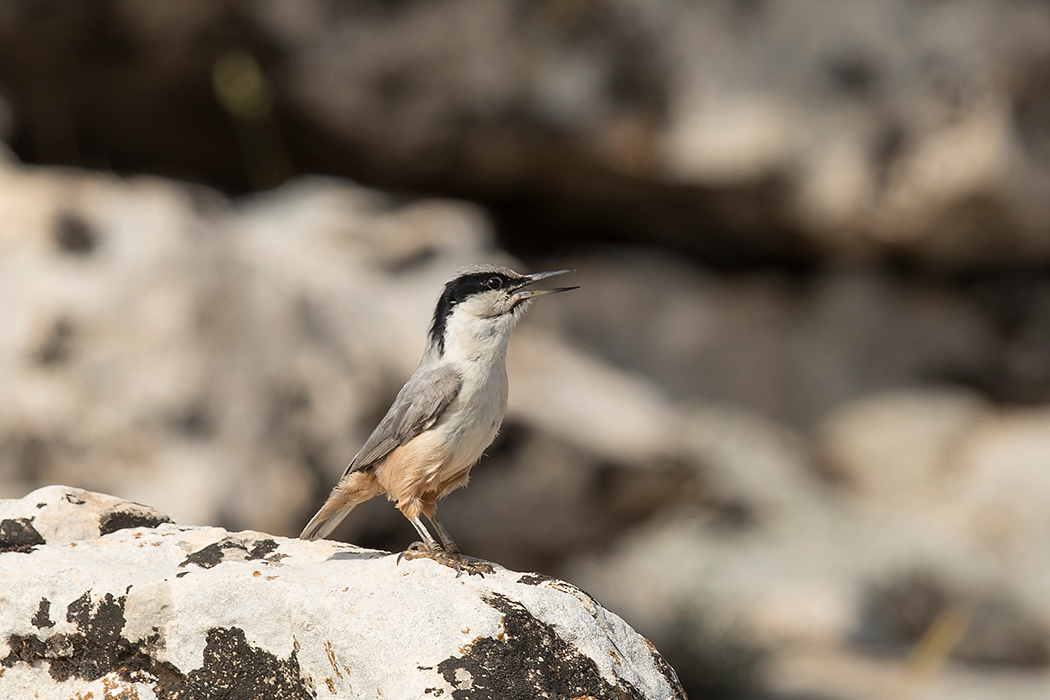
[533,250,999,431]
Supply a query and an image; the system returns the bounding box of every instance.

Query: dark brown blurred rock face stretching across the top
[6,0,1050,268]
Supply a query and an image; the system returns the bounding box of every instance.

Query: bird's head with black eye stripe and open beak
[431,264,579,353]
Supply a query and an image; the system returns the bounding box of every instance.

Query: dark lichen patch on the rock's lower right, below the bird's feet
[438,593,672,700]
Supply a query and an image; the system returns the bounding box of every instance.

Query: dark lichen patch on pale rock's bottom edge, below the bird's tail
[176,628,314,700]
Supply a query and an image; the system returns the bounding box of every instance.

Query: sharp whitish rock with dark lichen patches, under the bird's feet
[0,486,685,700]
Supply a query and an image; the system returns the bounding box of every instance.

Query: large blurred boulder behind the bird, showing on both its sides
[0,167,739,568]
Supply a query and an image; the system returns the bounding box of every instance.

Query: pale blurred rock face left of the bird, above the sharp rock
[0,165,503,532]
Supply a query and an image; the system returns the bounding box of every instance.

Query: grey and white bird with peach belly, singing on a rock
[299,263,580,577]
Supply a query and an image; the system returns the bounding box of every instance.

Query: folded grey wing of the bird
[342,366,463,476]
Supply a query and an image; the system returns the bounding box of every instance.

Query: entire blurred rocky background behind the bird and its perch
[0,0,1050,700]
